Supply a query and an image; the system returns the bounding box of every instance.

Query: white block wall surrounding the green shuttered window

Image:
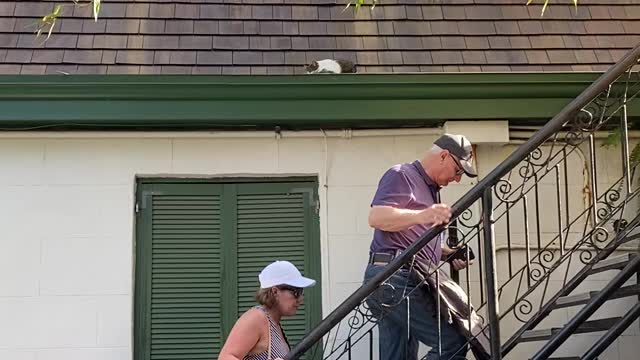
[0,129,640,360]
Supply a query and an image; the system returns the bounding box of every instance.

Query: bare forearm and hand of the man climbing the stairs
[369,204,451,232]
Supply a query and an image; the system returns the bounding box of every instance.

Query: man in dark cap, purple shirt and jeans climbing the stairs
[365,134,477,360]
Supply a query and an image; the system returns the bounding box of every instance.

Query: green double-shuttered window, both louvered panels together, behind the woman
[135,180,321,360]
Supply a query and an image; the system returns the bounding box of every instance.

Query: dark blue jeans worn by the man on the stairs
[365,265,468,360]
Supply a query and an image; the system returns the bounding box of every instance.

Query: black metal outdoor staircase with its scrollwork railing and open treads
[286,46,640,360]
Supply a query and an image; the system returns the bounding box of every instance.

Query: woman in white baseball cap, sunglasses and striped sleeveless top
[218,261,316,360]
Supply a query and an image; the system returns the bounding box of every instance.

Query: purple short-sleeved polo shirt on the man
[370,160,442,264]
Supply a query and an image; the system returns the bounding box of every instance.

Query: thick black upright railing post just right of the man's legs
[482,187,502,360]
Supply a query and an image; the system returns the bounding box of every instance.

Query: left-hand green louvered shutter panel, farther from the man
[136,184,222,360]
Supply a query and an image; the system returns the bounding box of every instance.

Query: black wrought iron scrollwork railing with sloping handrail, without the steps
[286,46,640,360]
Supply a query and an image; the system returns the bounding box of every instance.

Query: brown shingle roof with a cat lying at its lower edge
[0,0,640,74]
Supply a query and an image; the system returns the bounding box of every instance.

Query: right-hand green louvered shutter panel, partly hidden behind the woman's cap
[237,183,320,354]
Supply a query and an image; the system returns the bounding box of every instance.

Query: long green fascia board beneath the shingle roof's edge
[0,73,640,129]
